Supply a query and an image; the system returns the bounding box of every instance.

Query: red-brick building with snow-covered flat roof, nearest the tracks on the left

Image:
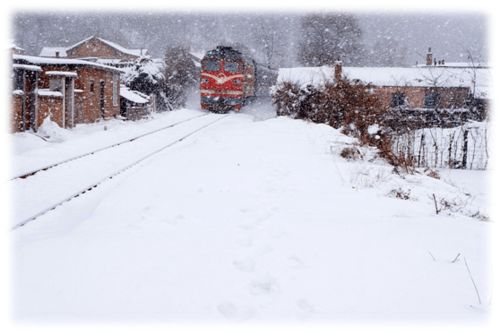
[12,55,121,131]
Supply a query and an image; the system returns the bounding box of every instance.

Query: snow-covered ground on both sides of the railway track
[11,104,491,322]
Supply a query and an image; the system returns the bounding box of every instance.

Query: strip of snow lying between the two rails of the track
[12,114,229,229]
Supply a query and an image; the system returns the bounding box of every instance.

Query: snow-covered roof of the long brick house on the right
[278,66,490,98]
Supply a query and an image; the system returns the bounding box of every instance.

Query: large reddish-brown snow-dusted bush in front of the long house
[272,78,413,172]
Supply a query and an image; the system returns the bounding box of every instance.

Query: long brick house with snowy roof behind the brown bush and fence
[278,55,490,126]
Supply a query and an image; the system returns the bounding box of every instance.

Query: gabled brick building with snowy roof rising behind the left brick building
[40,35,148,67]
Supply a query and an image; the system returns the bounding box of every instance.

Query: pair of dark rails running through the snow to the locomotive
[11,114,229,230]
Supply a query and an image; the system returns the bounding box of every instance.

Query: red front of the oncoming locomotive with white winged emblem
[200,46,255,112]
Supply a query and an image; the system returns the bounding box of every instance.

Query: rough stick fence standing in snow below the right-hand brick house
[393,122,489,170]
